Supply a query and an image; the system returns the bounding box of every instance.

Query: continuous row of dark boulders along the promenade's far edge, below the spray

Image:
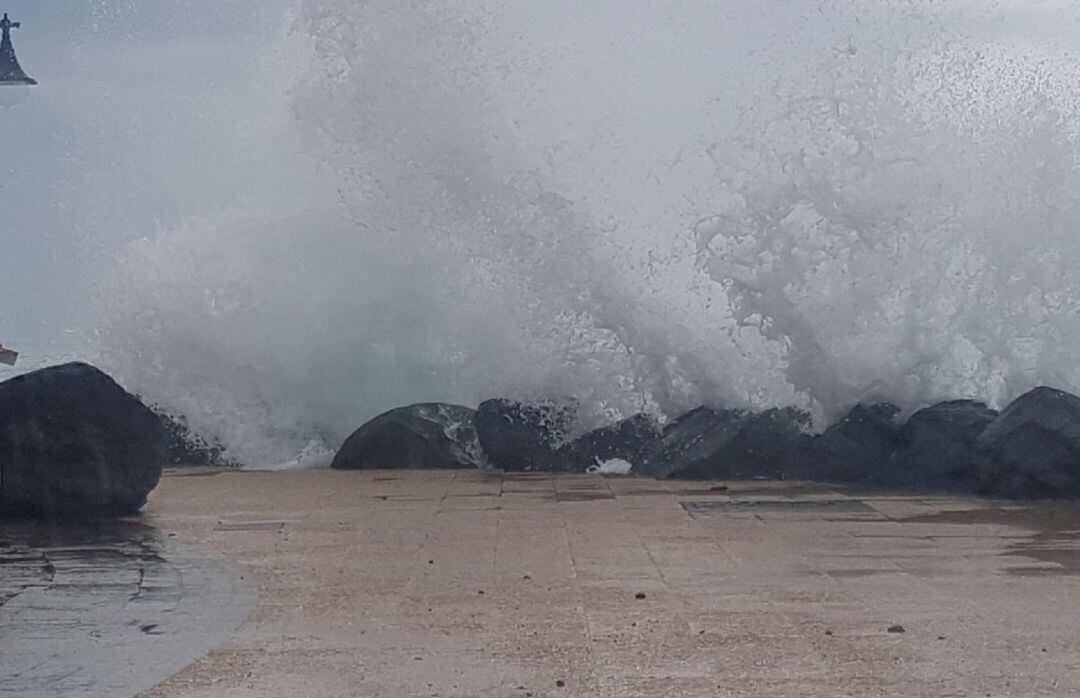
[334,388,1080,498]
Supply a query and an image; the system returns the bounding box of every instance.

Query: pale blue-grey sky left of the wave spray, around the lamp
[0,0,291,351]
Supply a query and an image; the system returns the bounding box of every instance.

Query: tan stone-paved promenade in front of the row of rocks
[132,471,1080,698]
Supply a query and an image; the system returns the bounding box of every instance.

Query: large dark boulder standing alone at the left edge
[0,363,167,516]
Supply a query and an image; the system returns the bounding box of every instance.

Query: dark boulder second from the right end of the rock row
[877,400,998,492]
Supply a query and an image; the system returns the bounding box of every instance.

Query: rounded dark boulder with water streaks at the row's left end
[330,402,483,470]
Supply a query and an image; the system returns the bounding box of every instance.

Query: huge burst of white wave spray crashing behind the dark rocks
[86,0,1080,464]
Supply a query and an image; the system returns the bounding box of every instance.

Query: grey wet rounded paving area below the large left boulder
[0,521,254,696]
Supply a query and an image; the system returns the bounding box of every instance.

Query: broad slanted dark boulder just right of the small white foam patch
[637,407,810,480]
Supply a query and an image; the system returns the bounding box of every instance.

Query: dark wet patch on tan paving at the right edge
[897,501,1080,577]
